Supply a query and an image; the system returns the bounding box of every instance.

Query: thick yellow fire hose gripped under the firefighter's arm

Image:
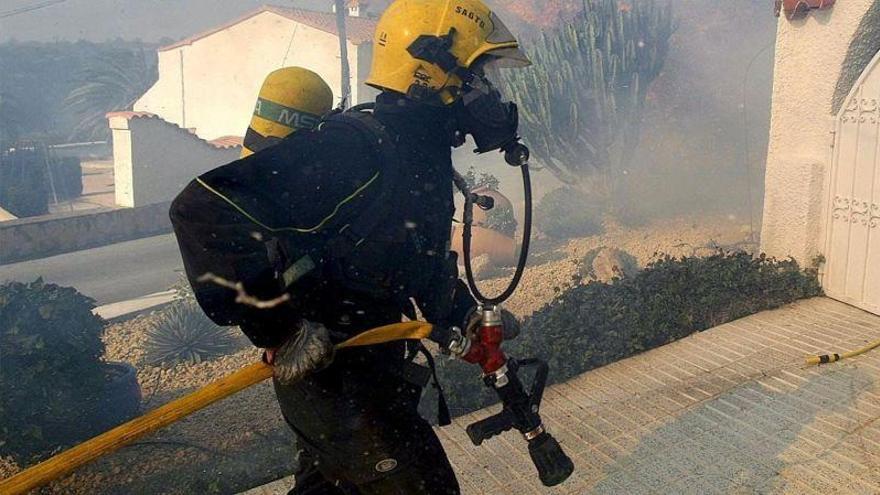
[0,321,433,495]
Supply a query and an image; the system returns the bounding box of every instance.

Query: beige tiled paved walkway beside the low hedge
[241,298,880,495]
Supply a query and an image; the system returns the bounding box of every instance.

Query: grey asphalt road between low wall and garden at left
[0,234,183,305]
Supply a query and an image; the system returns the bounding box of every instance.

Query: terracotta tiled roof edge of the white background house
[159,5,376,52]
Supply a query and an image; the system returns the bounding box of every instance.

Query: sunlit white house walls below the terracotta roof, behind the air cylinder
[134,0,376,140]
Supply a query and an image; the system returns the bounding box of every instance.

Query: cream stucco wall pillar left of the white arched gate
[761,0,874,263]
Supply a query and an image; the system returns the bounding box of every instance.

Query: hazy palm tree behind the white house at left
[64,50,158,140]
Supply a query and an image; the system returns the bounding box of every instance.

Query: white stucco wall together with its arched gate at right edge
[761,0,880,314]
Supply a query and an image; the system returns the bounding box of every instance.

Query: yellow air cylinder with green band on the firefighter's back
[241,67,333,158]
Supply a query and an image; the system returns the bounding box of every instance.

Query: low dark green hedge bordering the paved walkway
[437,252,822,414]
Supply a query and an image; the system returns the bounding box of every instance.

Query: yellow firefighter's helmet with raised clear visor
[366,0,530,104]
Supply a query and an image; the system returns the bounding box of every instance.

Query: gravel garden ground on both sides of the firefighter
[8,212,748,494]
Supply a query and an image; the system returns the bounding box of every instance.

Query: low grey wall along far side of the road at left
[0,202,171,265]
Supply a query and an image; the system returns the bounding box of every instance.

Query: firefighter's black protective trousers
[275,342,460,495]
